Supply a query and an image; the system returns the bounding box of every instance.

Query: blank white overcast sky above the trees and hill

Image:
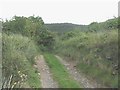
[0,0,119,24]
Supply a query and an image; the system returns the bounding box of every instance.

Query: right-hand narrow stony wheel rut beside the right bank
[55,55,101,88]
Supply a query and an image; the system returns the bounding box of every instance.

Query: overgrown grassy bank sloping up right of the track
[56,30,118,87]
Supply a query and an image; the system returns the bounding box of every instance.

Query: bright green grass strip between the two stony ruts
[44,53,81,88]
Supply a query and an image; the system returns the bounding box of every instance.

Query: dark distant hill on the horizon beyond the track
[45,23,86,32]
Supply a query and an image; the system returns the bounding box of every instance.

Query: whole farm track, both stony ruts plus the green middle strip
[36,54,105,88]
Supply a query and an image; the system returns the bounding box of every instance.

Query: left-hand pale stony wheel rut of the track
[36,55,58,88]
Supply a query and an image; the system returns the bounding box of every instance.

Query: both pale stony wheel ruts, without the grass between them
[36,55,105,88]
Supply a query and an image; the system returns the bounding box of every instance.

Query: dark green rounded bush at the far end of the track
[35,30,55,51]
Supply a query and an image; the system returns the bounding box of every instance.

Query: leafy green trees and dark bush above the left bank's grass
[3,16,54,50]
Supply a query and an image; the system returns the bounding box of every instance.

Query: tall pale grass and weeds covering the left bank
[2,33,40,88]
